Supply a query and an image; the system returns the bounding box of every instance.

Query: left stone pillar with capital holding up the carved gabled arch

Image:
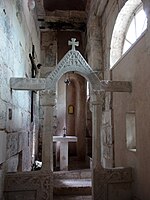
[41,90,55,171]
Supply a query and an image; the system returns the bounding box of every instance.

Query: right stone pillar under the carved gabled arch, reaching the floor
[91,91,104,200]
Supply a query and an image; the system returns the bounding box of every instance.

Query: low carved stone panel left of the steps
[4,171,53,200]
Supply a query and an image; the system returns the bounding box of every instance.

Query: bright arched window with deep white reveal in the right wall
[110,0,147,67]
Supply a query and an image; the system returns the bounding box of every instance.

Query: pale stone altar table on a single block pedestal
[53,136,77,170]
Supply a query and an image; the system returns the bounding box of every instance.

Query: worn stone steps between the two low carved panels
[53,169,92,197]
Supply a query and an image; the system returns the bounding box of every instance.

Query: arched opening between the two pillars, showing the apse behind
[55,72,87,170]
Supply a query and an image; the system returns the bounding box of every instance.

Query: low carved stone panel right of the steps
[92,167,133,200]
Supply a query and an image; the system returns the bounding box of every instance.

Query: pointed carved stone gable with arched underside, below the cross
[46,49,100,90]
